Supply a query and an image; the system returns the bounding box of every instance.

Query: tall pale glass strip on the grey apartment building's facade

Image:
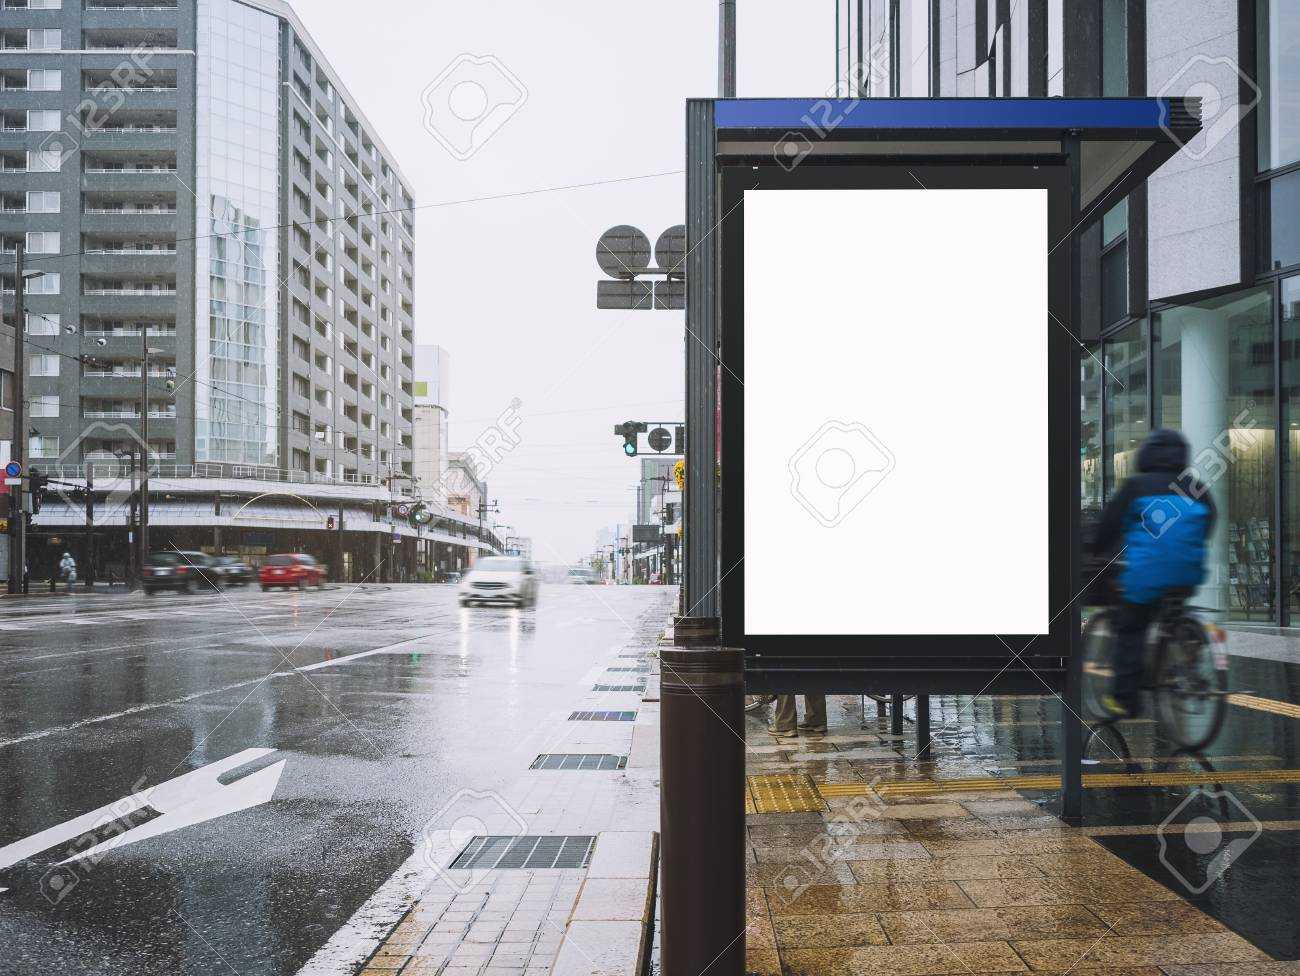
[195,0,281,465]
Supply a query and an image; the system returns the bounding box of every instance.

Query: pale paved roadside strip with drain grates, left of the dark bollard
[314,602,672,976]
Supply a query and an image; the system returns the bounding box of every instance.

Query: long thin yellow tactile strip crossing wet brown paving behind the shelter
[816,769,1300,797]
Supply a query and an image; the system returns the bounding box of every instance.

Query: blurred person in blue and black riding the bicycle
[1092,429,1216,719]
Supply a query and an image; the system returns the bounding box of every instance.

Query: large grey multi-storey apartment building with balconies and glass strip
[0,0,415,483]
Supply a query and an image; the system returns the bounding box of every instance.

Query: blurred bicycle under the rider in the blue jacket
[1083,590,1230,752]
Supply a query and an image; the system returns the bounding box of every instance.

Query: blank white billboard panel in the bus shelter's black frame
[744,188,1062,636]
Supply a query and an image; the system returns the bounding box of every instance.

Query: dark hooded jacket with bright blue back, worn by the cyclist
[1093,429,1217,603]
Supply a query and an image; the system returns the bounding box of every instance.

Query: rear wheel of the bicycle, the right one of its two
[1156,616,1227,752]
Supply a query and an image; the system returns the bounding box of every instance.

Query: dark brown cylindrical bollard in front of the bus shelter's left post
[659,617,745,976]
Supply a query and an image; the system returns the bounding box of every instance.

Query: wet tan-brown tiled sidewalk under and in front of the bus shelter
[745,698,1300,976]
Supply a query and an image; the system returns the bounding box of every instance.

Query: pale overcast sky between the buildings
[294,0,833,561]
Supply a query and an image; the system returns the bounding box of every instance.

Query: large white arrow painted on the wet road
[0,749,286,869]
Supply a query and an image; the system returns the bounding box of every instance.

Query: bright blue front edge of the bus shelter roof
[714,99,1170,131]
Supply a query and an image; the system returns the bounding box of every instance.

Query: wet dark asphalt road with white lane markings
[0,586,668,976]
